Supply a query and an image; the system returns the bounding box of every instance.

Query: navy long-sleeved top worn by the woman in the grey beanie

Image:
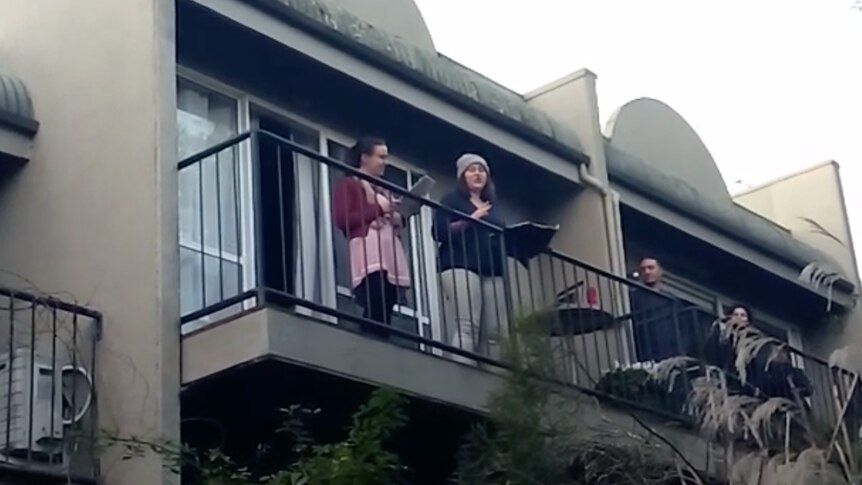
[432,190,506,276]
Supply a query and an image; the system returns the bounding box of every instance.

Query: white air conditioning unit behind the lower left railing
[0,347,64,460]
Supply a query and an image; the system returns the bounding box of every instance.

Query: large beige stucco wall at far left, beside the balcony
[0,0,179,485]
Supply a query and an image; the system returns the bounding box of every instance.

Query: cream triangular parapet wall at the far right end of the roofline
[734,162,862,357]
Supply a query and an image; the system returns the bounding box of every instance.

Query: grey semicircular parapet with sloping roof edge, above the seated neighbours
[605,98,849,290]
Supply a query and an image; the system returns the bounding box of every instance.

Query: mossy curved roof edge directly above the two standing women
[261,0,588,162]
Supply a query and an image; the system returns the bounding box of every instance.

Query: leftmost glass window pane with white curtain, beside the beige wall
[177,79,245,315]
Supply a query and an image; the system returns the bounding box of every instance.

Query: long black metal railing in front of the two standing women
[179,131,856,432]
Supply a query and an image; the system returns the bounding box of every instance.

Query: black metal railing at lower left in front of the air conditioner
[0,288,102,483]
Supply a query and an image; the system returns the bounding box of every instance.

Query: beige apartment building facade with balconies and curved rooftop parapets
[0,0,858,484]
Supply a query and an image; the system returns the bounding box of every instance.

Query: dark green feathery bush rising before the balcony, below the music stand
[453,315,698,485]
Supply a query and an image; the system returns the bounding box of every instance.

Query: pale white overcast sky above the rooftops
[416,0,862,256]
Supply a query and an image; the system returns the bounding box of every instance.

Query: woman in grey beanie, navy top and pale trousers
[433,153,508,360]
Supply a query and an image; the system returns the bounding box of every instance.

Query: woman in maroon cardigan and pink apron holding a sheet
[332,137,410,337]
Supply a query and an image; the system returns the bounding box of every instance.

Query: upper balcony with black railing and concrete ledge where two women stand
[174,130,849,434]
